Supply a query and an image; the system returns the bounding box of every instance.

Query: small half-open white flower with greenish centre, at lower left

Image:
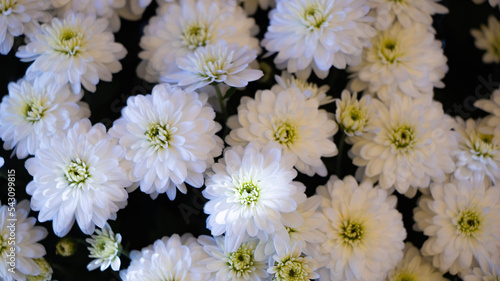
[85,223,122,271]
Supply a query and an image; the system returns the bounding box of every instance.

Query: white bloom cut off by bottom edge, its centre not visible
[120,234,209,281]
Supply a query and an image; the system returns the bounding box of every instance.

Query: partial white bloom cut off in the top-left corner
[0,0,50,55]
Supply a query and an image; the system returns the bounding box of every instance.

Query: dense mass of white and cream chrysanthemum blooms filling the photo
[0,0,500,281]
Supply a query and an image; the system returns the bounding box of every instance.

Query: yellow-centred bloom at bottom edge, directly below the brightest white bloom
[198,235,268,281]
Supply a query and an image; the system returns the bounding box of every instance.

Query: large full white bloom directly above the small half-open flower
[25,119,132,237]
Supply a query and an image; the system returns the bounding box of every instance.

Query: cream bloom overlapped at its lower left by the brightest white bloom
[226,87,338,177]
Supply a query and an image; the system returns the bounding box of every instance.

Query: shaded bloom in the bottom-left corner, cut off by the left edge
[0,200,47,281]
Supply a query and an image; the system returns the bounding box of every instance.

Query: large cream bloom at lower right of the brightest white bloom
[317,176,406,281]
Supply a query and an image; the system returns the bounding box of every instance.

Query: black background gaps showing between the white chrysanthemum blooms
[0,0,500,281]
